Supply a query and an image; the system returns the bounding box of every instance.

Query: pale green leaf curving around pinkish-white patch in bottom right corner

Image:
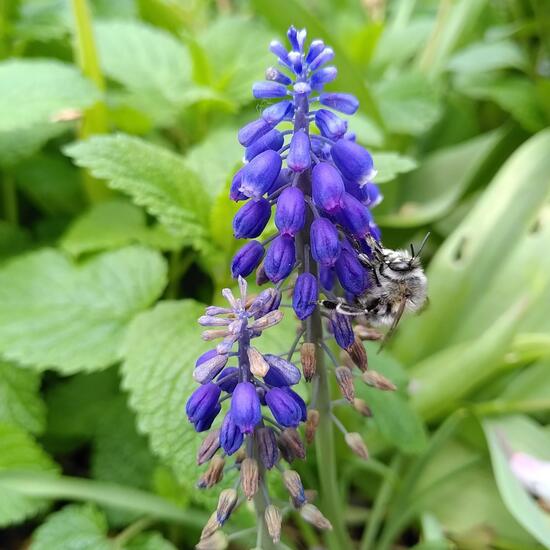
[483,416,550,546]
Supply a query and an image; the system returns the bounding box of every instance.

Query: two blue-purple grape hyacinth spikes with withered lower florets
[186,27,395,548]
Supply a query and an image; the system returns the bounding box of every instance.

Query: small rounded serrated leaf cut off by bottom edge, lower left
[30,504,113,550]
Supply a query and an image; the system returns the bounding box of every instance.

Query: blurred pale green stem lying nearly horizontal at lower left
[0,471,208,530]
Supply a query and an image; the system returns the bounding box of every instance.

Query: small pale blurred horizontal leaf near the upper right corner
[447,40,527,73]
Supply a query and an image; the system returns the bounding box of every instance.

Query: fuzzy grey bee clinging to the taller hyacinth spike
[322,233,429,348]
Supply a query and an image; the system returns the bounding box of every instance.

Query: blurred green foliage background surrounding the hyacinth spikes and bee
[0,0,550,550]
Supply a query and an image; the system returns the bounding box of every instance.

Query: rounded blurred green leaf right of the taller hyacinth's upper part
[375,72,441,136]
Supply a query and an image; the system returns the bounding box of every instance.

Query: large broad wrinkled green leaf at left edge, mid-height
[0,247,166,374]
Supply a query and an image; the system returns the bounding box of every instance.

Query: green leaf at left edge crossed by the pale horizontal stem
[0,424,57,527]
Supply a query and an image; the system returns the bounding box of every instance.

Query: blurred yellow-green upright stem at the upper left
[71,0,111,203]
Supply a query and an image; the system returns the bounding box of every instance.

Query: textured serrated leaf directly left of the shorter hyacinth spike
[122,300,212,486]
